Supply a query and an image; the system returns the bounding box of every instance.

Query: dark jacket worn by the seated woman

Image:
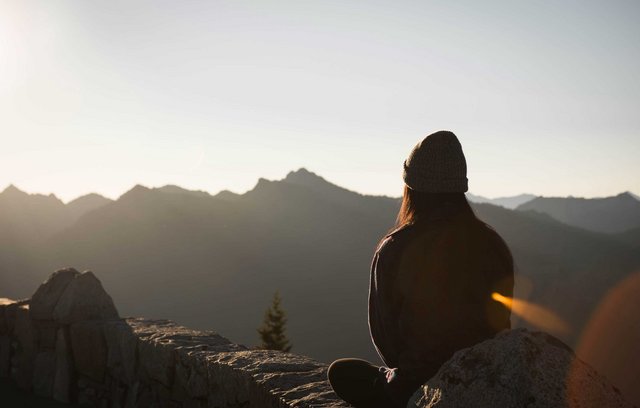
[369,214,513,403]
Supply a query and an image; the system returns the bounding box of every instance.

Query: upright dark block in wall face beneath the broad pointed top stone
[69,320,107,382]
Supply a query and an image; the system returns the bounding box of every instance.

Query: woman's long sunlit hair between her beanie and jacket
[394,185,476,229]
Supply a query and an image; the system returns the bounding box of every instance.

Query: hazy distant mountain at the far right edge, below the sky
[517,192,640,233]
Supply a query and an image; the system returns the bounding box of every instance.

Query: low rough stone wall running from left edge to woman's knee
[0,269,347,408]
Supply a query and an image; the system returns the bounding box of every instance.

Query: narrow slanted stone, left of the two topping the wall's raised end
[31,268,80,320]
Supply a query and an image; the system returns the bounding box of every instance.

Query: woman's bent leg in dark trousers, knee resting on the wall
[327,358,393,408]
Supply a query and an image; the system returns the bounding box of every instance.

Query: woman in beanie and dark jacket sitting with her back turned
[327,131,513,407]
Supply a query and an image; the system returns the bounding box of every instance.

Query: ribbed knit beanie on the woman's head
[403,130,469,193]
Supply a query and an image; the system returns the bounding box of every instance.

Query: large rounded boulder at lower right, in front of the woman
[408,329,631,408]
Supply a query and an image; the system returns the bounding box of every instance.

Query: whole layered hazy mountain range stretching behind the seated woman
[0,169,640,396]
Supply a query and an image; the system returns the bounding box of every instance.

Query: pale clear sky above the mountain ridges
[0,0,640,201]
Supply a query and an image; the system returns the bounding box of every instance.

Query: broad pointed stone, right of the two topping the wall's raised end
[53,271,119,324]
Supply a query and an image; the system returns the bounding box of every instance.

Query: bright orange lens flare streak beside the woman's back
[491,292,570,335]
